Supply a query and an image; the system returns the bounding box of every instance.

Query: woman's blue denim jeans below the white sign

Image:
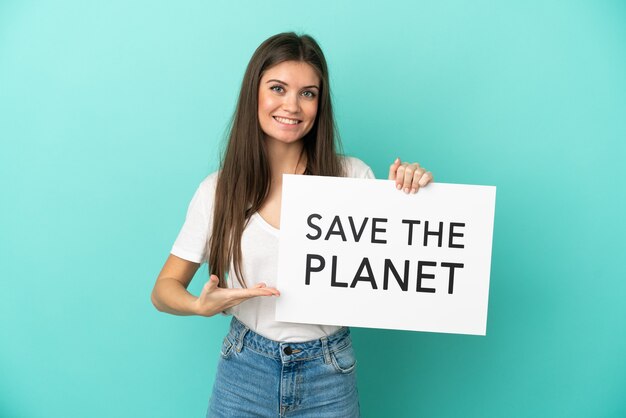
[206,317,360,418]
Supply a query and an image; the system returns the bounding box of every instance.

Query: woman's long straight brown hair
[208,32,343,287]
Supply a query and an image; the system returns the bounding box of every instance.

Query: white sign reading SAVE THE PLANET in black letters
[276,175,496,335]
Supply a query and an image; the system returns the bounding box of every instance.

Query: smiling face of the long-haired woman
[259,61,320,143]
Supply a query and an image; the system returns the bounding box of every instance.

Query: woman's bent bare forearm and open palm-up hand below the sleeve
[152,254,280,316]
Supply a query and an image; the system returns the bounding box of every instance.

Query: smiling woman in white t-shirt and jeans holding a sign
[152,33,432,417]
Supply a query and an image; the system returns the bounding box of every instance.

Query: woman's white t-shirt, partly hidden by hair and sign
[171,157,374,342]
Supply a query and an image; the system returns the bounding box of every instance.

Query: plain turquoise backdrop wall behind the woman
[0,0,626,418]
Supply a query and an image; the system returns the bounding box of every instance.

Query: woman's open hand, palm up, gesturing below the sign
[193,274,280,316]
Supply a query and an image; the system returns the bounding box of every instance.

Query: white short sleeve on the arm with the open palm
[170,173,217,263]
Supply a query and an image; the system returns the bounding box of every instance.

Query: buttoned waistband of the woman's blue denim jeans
[226,316,352,363]
